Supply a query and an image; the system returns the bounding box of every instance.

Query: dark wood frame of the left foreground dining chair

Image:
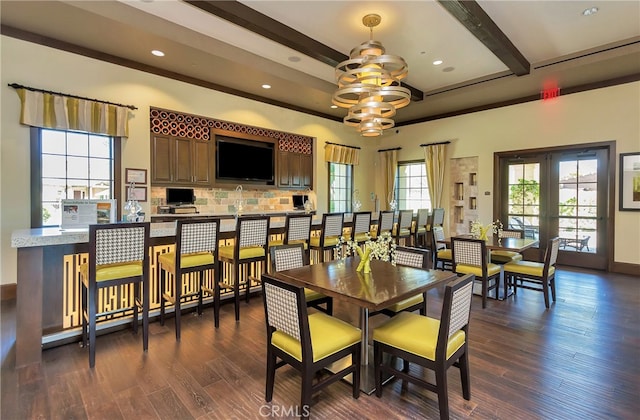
[262,275,362,418]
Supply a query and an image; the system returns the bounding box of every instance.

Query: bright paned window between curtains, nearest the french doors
[396,162,431,211]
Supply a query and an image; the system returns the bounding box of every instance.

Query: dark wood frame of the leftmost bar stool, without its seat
[80,222,151,368]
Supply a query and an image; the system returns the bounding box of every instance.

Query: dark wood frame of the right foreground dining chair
[373,274,474,419]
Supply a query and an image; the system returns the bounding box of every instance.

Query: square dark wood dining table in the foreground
[264,257,457,394]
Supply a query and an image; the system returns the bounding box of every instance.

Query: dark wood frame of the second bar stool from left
[157,218,220,340]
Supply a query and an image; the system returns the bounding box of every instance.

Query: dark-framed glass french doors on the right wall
[494,142,615,269]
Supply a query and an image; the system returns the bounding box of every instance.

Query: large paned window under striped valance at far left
[31,129,119,227]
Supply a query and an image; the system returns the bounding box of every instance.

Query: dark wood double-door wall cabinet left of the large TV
[151,136,213,187]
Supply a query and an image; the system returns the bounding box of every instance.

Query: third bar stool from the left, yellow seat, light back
[213,216,269,322]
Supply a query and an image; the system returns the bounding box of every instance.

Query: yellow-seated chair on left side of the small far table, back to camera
[451,236,502,309]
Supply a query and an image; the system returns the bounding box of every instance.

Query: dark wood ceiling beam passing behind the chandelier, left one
[185,0,424,102]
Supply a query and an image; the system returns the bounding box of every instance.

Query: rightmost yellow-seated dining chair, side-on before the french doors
[503,237,560,309]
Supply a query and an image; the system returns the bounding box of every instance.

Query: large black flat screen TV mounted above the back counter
[216,136,275,185]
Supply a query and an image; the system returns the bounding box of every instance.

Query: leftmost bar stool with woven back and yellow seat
[79,222,150,368]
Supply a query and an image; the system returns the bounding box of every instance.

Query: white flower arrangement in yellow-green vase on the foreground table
[334,232,396,273]
